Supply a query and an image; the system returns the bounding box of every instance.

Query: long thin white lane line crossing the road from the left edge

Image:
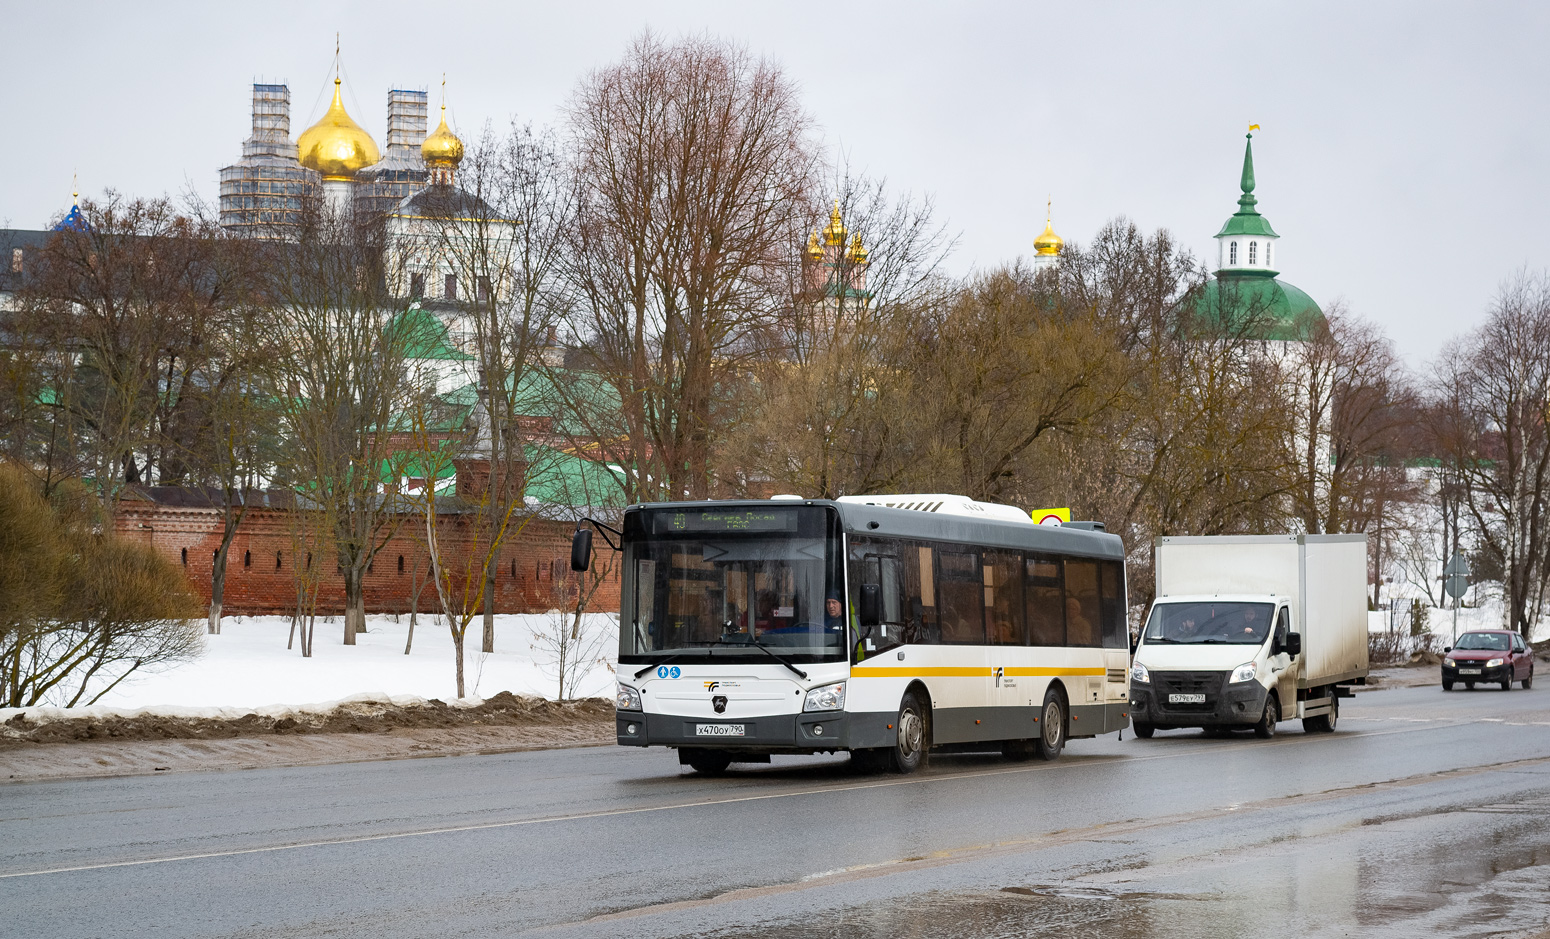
[0,721,1512,880]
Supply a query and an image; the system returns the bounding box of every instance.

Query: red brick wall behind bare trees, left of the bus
[115,500,620,615]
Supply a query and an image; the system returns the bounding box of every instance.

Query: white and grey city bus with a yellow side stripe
[572,496,1128,773]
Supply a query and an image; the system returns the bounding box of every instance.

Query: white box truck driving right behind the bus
[1130,535,1367,738]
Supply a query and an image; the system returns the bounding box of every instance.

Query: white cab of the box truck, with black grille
[1130,593,1302,738]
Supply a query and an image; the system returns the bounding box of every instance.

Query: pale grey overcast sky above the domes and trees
[0,0,1550,367]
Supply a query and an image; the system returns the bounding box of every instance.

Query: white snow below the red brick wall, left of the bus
[72,614,618,710]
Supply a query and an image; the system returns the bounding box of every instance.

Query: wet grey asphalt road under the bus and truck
[0,686,1550,939]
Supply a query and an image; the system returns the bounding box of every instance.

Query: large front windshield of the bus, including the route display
[620,507,848,662]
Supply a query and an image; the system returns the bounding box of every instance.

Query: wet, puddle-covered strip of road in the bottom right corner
[713,795,1550,939]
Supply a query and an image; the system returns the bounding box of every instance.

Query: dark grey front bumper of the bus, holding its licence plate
[614,711,897,753]
